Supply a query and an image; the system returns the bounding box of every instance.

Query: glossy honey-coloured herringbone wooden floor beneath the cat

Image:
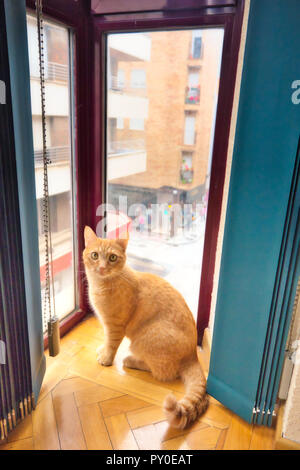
[0,317,274,450]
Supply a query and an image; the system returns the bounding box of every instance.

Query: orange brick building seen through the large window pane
[108,29,222,204]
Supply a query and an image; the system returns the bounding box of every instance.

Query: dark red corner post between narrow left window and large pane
[26,0,95,342]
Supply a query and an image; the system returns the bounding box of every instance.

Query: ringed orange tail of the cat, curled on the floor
[164,359,208,429]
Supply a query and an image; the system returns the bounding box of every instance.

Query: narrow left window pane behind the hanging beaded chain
[27,15,75,327]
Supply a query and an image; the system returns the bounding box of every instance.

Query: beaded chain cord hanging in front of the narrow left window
[36,0,56,328]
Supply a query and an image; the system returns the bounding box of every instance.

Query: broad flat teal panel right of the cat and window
[208,0,300,419]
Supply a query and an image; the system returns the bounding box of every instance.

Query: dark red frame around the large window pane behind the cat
[94,0,244,343]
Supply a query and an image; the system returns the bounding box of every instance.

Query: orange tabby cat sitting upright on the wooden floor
[83,227,208,428]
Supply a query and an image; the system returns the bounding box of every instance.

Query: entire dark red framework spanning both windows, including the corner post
[26,0,244,342]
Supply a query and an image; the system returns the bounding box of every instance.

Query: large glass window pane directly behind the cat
[106,28,223,317]
